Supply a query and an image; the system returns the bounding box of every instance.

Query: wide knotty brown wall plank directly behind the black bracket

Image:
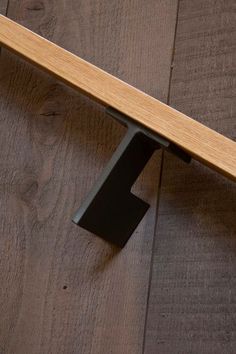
[0,0,177,354]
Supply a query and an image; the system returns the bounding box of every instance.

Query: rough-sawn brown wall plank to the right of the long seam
[145,0,236,354]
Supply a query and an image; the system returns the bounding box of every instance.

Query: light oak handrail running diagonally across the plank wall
[0,16,236,181]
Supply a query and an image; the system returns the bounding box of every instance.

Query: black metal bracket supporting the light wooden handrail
[73,107,191,247]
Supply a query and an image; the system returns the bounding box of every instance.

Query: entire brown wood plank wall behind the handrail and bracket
[0,0,236,354]
